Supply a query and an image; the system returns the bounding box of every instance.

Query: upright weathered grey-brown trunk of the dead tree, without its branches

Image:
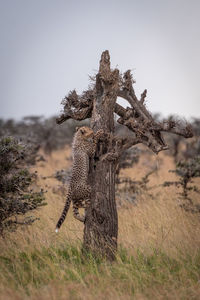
[83,51,119,260]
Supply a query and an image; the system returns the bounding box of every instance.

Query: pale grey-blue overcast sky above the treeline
[0,0,200,119]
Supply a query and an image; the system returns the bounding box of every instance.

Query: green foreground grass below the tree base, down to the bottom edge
[0,245,200,299]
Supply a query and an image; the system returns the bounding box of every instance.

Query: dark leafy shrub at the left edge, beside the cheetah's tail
[0,137,45,234]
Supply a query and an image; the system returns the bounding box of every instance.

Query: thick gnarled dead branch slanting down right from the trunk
[115,70,192,153]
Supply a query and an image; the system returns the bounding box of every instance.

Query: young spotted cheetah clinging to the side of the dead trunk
[56,126,103,232]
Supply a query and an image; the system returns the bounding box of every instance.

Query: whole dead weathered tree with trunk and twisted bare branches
[57,50,192,259]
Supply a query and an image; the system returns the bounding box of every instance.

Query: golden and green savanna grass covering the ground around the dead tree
[0,148,200,300]
